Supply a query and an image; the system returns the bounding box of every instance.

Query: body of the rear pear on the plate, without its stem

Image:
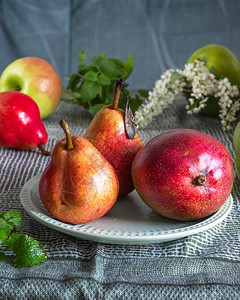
[84,105,144,197]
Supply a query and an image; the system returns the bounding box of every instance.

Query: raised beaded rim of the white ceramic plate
[20,173,233,245]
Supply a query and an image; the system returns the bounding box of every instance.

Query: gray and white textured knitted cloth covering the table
[0,99,240,299]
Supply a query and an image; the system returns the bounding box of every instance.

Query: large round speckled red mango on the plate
[132,129,234,220]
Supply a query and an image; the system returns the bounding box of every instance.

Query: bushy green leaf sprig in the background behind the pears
[64,50,146,115]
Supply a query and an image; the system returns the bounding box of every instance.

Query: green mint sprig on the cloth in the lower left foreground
[0,210,47,267]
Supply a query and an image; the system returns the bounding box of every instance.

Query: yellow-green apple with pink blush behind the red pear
[0,57,62,119]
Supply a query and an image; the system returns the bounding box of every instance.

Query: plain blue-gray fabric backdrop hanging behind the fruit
[0,0,240,89]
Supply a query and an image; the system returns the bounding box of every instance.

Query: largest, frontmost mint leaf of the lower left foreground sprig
[13,235,47,267]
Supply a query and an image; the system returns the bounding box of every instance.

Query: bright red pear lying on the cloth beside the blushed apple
[0,91,48,150]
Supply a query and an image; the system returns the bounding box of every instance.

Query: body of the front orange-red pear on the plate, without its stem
[39,136,119,224]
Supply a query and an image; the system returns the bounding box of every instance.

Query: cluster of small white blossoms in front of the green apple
[135,60,240,130]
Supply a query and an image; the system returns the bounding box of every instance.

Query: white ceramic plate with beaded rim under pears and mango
[20,174,233,245]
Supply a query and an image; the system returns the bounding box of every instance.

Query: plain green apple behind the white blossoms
[188,44,240,118]
